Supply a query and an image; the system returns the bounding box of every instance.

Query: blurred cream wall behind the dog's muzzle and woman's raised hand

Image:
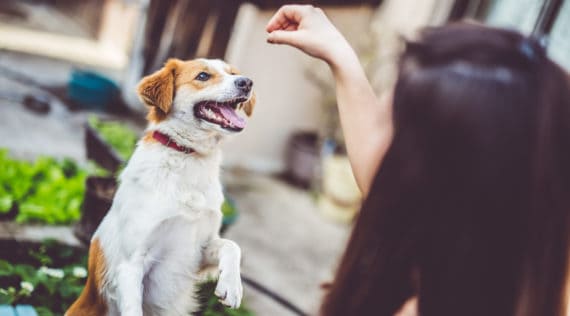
[224,4,374,172]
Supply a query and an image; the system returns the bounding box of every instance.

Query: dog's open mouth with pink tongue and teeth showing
[194,98,247,132]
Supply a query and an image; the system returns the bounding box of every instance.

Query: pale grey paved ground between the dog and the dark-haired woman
[224,172,349,315]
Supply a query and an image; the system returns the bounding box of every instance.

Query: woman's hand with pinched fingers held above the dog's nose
[266,5,353,68]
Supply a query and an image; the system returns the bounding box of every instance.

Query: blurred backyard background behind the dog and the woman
[0,0,570,315]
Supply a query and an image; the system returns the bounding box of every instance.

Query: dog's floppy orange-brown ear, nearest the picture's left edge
[137,59,181,117]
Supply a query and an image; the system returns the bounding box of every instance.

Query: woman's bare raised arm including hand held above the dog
[266,5,393,195]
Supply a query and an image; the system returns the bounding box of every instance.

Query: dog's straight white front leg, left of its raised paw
[117,253,144,316]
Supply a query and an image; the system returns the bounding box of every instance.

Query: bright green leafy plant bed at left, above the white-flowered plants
[0,149,87,224]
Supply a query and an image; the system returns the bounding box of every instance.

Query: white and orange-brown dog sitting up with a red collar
[65,59,255,316]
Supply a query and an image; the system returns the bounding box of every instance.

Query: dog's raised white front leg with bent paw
[204,237,243,308]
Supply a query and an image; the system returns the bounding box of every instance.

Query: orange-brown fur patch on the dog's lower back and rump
[65,238,108,316]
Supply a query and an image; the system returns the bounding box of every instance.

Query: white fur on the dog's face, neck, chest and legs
[69,60,251,316]
